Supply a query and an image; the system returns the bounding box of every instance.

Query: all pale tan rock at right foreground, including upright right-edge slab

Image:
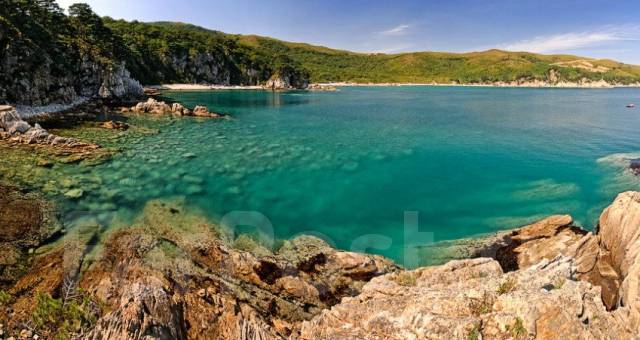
[301,192,640,339]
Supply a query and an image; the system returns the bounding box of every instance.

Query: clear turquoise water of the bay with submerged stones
[60,87,640,263]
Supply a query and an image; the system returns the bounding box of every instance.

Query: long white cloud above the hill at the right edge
[499,26,640,53]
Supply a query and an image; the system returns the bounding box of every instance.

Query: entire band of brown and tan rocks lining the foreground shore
[0,192,640,339]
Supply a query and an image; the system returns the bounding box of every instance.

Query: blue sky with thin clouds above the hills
[58,0,640,64]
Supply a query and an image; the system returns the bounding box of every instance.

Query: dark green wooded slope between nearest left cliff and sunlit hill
[104,18,306,85]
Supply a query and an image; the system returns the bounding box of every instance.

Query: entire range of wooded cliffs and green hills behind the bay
[0,0,640,105]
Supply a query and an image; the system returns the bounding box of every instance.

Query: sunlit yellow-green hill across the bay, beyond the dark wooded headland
[238,36,640,84]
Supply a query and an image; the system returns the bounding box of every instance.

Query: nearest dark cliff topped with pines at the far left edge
[0,1,142,106]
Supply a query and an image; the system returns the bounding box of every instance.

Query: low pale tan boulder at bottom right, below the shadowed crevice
[300,257,631,339]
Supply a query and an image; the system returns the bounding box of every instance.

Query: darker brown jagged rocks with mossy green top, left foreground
[0,201,398,339]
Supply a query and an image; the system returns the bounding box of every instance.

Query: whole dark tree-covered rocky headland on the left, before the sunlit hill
[0,0,308,106]
